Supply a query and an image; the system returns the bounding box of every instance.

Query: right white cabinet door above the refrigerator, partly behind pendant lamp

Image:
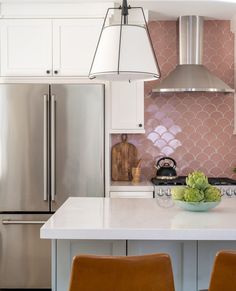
[53,19,103,77]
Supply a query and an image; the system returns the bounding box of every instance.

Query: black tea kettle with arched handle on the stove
[154,157,177,180]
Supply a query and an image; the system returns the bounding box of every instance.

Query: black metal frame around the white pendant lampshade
[89,0,161,79]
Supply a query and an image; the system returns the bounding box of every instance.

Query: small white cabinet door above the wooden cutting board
[111,81,144,133]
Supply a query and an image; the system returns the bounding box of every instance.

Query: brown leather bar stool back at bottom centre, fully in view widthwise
[69,254,175,291]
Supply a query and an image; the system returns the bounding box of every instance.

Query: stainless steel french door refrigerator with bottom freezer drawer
[0,84,104,290]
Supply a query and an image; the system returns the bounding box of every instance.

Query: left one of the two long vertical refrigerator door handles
[43,94,48,201]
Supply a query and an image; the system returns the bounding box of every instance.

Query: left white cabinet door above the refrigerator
[0,19,52,76]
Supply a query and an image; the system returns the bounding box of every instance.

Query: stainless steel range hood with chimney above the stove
[152,16,234,93]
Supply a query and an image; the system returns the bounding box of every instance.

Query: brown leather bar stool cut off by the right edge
[209,251,236,291]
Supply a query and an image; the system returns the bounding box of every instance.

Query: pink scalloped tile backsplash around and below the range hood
[112,20,236,179]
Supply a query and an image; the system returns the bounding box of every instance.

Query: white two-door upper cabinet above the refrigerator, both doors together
[0,19,102,77]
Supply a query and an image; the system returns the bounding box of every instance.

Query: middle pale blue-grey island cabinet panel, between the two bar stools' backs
[128,240,197,291]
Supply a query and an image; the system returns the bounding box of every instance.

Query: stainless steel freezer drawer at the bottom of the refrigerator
[0,214,51,289]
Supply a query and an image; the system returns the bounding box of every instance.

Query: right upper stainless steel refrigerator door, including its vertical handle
[51,84,104,210]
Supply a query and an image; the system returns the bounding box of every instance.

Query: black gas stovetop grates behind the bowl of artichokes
[151,176,236,186]
